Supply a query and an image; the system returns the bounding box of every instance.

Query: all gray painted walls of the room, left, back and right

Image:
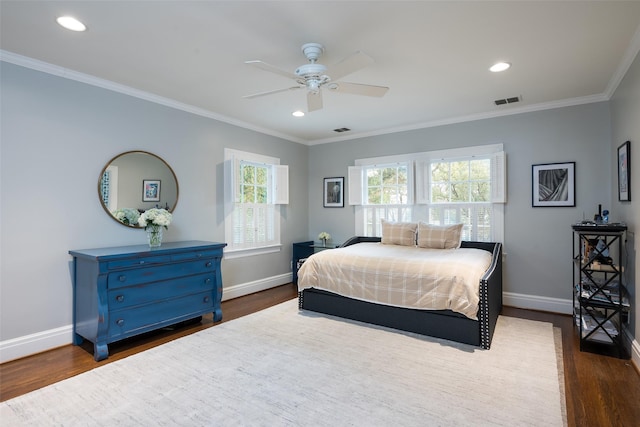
[0,54,640,358]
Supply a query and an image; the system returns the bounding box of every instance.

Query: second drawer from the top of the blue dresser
[107,259,216,289]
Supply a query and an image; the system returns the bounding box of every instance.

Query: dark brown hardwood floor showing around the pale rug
[0,284,640,427]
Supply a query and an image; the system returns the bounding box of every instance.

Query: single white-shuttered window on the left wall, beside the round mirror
[225,149,288,256]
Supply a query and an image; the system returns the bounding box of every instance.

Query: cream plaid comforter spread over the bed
[298,243,491,320]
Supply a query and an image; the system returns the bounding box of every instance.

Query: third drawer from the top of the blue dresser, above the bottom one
[108,274,215,311]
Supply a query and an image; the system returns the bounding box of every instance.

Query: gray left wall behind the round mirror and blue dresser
[0,62,308,342]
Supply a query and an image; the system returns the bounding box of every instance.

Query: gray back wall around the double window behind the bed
[309,102,615,307]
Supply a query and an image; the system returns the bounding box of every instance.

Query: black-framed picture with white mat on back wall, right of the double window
[531,162,576,207]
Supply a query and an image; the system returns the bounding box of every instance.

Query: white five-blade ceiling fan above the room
[243,43,389,112]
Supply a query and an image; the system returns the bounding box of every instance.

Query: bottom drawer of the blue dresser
[108,292,213,342]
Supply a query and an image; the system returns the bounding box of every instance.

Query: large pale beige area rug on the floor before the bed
[0,300,563,427]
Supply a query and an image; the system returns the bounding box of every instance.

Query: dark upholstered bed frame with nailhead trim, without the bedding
[298,236,502,349]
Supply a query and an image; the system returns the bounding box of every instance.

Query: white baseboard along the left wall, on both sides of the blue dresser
[0,273,291,363]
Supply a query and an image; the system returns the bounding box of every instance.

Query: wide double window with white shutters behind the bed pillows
[349,144,506,242]
